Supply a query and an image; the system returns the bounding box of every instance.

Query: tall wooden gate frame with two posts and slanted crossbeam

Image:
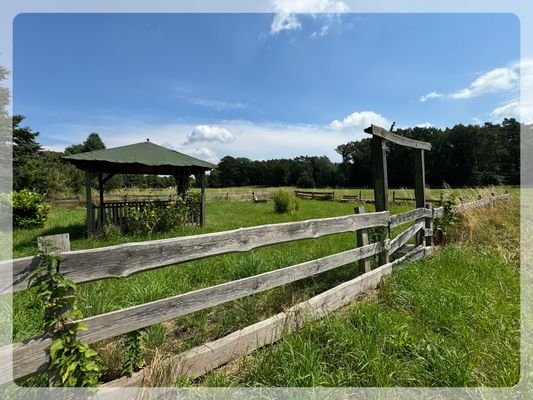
[365,125,431,256]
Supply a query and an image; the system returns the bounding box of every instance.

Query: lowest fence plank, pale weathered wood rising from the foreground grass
[103,247,425,387]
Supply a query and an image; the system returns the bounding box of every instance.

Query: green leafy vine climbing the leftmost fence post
[28,247,102,387]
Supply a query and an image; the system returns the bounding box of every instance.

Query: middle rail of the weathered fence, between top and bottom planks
[0,243,383,384]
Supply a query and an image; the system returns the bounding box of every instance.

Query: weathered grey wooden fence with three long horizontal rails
[0,195,508,384]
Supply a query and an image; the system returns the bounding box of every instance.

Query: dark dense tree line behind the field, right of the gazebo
[209,119,520,188]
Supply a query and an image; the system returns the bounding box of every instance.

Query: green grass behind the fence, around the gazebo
[6,186,516,385]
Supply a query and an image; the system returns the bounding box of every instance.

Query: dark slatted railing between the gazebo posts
[90,200,202,231]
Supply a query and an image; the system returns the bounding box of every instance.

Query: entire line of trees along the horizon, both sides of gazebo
[12,115,521,195]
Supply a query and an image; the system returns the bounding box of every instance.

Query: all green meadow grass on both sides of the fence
[6,189,519,386]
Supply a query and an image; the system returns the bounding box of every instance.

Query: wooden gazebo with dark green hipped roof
[63,140,216,236]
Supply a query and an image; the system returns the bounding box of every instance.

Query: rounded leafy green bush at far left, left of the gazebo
[11,189,50,228]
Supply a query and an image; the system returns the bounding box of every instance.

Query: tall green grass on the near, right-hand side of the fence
[191,195,520,387]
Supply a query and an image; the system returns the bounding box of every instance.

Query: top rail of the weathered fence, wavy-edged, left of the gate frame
[0,212,389,293]
